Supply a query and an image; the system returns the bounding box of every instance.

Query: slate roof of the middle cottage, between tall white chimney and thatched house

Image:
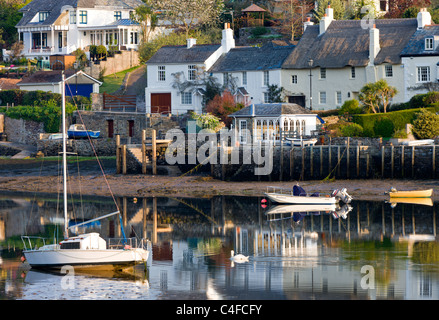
[209,43,294,72]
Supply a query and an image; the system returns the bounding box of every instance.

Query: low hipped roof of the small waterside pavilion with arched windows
[229,103,313,117]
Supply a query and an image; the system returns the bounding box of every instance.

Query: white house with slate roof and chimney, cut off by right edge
[401,9,439,101]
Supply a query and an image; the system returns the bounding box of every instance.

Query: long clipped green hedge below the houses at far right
[352,106,439,137]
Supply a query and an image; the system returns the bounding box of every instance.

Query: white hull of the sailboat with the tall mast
[23,248,149,268]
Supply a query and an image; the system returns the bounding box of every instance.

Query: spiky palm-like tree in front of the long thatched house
[358,79,398,113]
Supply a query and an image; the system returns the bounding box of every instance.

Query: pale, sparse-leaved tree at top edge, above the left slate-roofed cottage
[152,0,224,36]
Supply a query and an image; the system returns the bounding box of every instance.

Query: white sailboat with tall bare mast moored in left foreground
[22,74,149,269]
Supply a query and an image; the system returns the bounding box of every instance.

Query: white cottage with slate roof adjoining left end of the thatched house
[208,42,294,106]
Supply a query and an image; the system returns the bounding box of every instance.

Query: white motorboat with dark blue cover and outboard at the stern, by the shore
[265,185,352,205]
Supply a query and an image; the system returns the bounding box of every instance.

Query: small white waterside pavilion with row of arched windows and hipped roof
[229,103,317,144]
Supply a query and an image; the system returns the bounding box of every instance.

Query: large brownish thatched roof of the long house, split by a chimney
[282,19,417,69]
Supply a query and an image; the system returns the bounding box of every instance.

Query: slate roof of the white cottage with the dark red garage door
[146,44,220,64]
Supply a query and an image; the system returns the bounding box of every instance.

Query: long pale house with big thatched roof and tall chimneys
[281,8,418,110]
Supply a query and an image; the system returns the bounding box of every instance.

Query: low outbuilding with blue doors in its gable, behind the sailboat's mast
[17,70,102,98]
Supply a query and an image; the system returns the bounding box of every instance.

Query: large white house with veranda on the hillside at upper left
[3,0,143,60]
